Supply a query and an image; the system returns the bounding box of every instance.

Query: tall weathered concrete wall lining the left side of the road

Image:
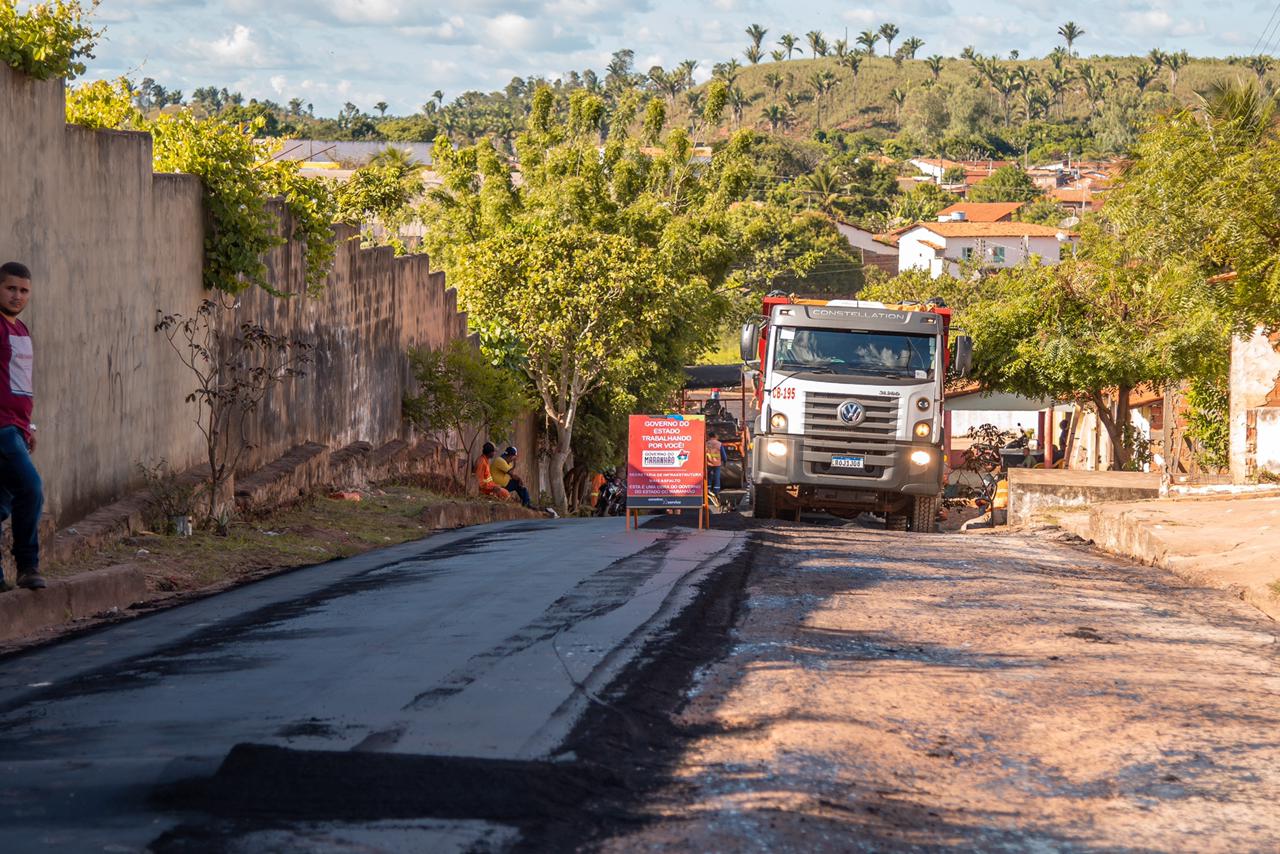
[0,65,476,524]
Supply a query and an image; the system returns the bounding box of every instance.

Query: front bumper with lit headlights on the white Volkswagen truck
[751,435,942,503]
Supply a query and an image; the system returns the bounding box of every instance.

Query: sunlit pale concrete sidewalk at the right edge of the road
[1053,494,1280,620]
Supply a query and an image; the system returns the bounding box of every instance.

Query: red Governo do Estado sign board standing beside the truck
[627,415,707,510]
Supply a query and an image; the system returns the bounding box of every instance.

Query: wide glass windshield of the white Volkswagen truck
[773,326,937,379]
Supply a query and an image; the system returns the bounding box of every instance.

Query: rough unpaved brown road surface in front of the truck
[591,524,1280,851]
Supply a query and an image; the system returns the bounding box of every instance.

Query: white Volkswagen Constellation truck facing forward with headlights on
[741,294,973,531]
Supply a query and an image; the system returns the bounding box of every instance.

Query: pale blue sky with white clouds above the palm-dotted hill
[82,0,1280,114]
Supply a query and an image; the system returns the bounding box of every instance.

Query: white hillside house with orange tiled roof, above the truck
[897,219,1078,278]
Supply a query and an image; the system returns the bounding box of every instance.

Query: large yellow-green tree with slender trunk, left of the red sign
[425,87,753,510]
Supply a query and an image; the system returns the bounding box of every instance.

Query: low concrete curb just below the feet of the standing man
[0,565,147,641]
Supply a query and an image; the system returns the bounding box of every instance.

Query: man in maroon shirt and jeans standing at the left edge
[0,261,45,590]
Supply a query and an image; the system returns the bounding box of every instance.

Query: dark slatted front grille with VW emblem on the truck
[804,392,899,478]
